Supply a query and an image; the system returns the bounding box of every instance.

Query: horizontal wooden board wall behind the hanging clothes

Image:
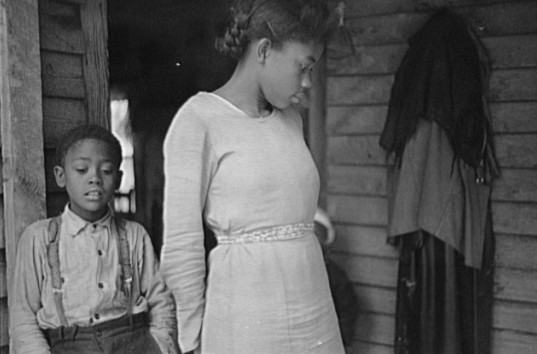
[323,0,537,354]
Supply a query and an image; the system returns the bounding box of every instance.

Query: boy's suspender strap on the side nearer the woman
[114,217,134,317]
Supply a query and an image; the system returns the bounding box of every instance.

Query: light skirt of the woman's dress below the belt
[201,224,344,354]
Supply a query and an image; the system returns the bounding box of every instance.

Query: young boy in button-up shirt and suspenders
[9,125,178,354]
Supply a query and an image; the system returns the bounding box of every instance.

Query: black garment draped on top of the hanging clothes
[380,10,489,167]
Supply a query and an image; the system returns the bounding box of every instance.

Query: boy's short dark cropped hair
[54,124,123,168]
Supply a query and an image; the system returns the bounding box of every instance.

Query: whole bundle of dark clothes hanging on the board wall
[380,10,496,354]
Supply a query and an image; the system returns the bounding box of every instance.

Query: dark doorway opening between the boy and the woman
[108,0,234,253]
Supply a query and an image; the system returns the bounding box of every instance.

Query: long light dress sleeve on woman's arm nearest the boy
[161,109,215,352]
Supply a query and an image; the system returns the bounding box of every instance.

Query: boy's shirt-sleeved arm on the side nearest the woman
[139,227,180,354]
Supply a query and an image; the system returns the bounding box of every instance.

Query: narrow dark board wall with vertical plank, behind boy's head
[39,0,110,216]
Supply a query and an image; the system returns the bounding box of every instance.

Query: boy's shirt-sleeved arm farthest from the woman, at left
[9,227,50,354]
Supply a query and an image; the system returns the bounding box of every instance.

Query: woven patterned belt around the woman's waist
[216,223,313,245]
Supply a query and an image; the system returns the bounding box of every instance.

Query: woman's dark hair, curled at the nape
[216,0,332,59]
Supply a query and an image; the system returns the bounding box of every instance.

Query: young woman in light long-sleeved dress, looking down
[161,0,344,354]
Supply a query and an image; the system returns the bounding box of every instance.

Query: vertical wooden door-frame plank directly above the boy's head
[80,0,110,129]
